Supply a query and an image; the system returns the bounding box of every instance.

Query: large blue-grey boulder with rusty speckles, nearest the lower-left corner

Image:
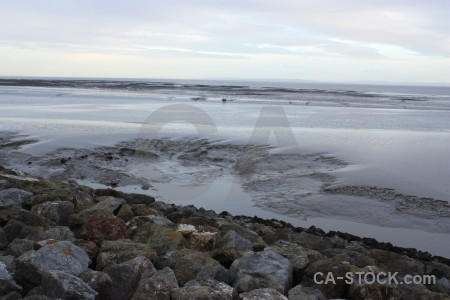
[14,241,90,289]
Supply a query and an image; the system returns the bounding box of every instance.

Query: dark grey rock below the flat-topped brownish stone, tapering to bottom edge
[103,256,156,300]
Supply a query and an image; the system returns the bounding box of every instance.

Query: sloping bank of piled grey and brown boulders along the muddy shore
[0,167,450,300]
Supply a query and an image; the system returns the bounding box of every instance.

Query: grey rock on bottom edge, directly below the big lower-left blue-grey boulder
[41,271,98,300]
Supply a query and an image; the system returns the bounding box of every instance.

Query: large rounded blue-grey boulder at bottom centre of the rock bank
[230,250,292,294]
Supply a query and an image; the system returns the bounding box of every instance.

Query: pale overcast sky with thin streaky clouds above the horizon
[0,0,450,83]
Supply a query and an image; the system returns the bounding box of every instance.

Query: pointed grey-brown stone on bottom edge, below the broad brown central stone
[132,268,178,300]
